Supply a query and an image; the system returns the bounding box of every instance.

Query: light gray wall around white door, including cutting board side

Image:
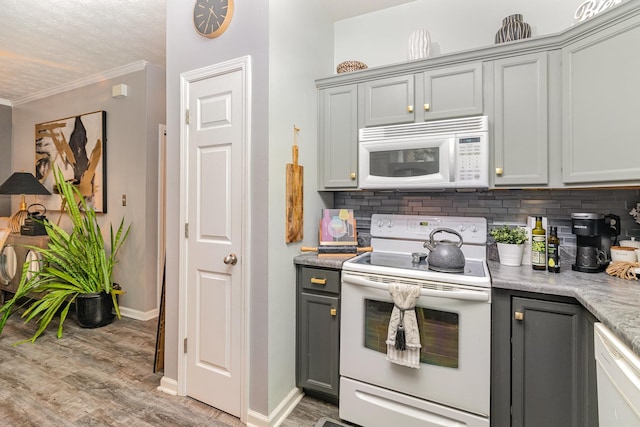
[165,0,333,418]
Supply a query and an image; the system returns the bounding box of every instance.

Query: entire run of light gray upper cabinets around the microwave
[316,0,640,191]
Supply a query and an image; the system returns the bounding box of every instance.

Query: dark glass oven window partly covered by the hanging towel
[364,299,460,368]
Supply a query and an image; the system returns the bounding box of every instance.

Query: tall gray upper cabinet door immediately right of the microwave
[490,52,549,187]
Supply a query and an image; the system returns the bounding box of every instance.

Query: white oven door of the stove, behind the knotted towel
[340,271,491,422]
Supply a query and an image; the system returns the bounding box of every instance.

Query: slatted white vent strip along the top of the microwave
[360,116,489,141]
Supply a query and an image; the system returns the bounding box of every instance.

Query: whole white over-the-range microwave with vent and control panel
[358,116,489,191]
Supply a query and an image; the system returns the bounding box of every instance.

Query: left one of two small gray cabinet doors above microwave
[360,75,415,127]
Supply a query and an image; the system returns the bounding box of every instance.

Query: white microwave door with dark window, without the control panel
[358,136,455,190]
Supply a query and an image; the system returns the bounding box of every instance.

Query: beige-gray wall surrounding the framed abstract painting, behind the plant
[12,64,165,318]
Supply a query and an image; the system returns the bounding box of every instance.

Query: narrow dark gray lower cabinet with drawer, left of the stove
[296,266,340,402]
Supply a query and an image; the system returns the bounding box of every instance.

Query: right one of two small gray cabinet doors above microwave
[420,62,482,120]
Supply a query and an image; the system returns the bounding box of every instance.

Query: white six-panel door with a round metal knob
[184,59,248,417]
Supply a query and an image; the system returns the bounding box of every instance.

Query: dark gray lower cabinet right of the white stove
[491,289,598,427]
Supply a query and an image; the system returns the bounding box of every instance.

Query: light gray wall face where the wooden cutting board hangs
[266,0,333,413]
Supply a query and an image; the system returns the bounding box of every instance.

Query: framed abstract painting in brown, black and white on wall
[35,111,107,212]
